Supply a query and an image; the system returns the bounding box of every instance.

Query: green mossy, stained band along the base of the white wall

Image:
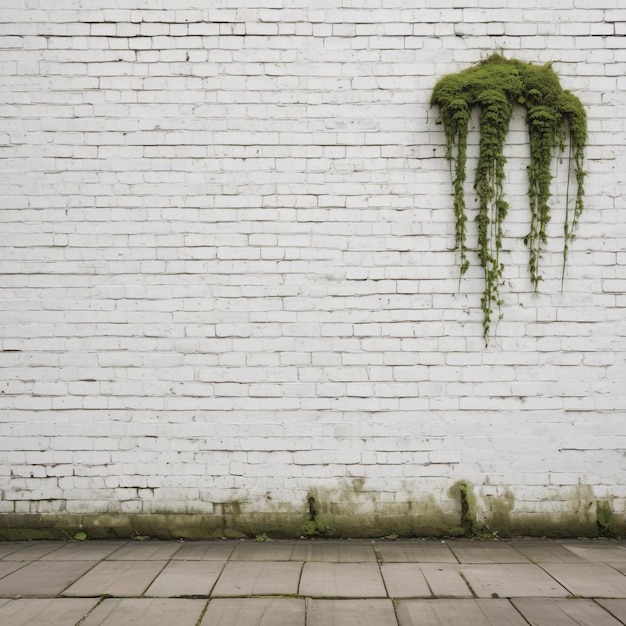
[0,480,626,539]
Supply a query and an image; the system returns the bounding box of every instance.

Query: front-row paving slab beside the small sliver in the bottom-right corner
[511,598,621,626]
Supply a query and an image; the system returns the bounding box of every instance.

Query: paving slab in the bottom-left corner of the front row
[0,598,98,626]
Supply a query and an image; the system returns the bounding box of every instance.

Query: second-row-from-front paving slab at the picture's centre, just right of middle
[300,563,387,598]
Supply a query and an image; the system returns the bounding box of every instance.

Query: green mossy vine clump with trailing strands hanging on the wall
[431,54,587,340]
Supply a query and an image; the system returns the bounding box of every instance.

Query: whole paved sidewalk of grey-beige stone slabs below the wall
[0,539,626,626]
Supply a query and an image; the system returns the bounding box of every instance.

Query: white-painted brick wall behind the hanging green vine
[0,0,626,532]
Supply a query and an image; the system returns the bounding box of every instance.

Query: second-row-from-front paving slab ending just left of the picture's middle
[211,561,302,597]
